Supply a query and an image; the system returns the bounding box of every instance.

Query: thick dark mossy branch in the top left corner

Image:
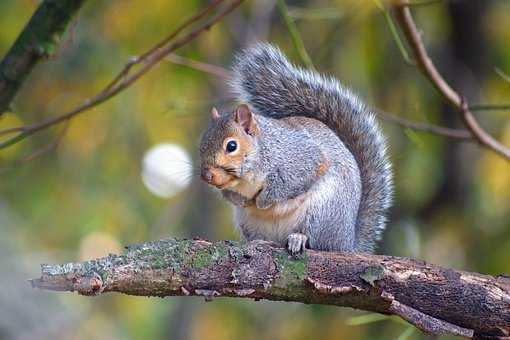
[0,0,86,115]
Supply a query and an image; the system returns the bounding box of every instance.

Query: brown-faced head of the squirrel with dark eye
[200,104,259,189]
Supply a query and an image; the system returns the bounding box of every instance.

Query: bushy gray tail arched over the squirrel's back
[231,44,392,252]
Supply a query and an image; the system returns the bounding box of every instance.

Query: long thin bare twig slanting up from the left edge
[0,0,244,149]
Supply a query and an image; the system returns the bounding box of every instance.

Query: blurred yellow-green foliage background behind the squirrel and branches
[0,0,510,339]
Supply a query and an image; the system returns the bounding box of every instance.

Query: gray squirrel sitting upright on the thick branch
[200,43,392,255]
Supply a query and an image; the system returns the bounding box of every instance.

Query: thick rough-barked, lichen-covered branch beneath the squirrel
[31,239,510,339]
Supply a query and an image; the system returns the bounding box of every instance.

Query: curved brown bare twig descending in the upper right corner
[394,0,510,161]
